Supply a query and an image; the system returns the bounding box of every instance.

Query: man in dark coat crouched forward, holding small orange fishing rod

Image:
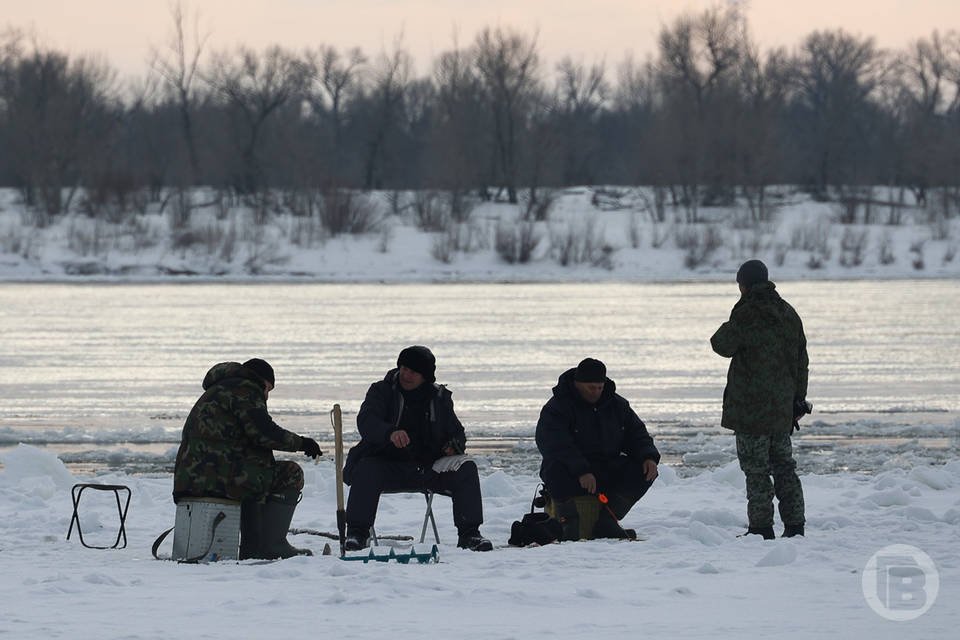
[536,358,660,540]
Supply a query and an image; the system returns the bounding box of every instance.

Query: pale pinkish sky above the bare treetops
[0,0,960,76]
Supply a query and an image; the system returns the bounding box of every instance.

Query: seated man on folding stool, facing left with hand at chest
[343,346,493,551]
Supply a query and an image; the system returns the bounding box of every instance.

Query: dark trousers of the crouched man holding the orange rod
[541,456,653,518]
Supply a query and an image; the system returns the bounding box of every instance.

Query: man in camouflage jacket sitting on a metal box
[173,358,322,560]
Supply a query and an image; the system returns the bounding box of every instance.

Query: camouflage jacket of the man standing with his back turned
[710,282,809,435]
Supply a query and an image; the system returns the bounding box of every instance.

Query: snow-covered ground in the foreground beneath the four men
[0,445,960,640]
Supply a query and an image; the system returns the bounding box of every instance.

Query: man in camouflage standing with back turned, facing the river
[710,260,809,540]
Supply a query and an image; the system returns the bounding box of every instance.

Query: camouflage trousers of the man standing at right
[737,433,804,527]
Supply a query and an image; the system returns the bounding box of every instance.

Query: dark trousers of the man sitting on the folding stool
[347,456,483,533]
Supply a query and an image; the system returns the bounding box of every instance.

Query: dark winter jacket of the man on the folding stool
[343,369,467,484]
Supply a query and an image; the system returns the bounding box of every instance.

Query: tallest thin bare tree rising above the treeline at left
[151,0,210,184]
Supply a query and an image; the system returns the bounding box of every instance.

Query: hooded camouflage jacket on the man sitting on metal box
[173,362,303,501]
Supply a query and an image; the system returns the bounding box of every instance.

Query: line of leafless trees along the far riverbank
[0,4,960,223]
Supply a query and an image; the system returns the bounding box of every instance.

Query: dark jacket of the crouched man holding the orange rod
[536,369,660,478]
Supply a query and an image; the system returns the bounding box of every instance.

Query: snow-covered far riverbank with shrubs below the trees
[0,187,960,282]
